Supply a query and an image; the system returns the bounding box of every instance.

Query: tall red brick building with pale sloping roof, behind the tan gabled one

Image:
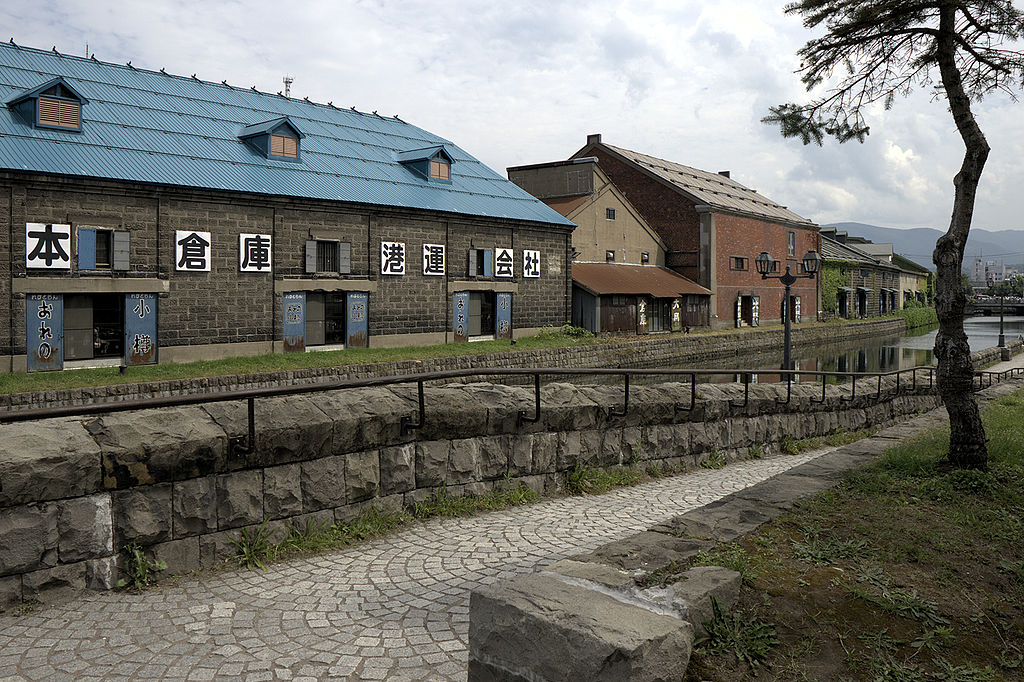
[572,135,819,327]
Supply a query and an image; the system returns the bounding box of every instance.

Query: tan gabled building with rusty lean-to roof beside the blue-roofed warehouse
[508,157,711,334]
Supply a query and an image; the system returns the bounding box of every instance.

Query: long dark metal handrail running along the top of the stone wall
[0,367,1024,453]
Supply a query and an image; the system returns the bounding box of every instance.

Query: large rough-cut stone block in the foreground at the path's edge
[469,573,693,682]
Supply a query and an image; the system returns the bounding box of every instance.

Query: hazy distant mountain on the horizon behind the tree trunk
[822,222,1024,270]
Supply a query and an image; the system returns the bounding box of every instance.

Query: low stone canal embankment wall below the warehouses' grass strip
[0,317,905,409]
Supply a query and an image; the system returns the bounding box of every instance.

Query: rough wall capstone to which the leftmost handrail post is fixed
[204,394,334,468]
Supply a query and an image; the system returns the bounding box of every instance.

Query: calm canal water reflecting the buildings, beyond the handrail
[679,315,1024,372]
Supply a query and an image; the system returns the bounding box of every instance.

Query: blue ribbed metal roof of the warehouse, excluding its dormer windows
[0,43,572,226]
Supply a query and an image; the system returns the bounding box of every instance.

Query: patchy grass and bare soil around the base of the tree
[686,392,1024,682]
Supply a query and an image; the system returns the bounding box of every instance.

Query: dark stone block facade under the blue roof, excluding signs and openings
[0,172,571,372]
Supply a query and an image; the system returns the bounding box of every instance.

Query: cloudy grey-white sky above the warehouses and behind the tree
[6,0,1024,229]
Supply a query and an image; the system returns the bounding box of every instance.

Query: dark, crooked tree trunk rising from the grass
[932,5,989,469]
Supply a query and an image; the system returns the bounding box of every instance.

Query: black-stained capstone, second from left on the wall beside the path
[87,408,227,489]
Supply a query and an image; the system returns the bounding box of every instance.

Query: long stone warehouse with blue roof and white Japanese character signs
[0,43,573,371]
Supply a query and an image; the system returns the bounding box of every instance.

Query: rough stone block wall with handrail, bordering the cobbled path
[0,360,938,608]
